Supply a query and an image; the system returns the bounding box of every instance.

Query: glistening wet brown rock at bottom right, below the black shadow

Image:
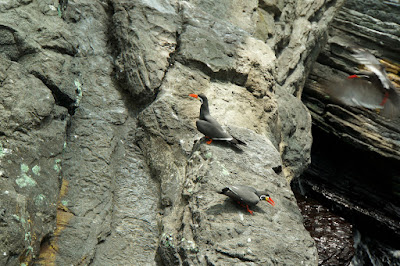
[292,179,400,266]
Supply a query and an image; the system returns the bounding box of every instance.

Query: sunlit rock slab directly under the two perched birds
[139,63,316,265]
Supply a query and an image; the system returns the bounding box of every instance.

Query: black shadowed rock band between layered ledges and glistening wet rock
[301,125,400,242]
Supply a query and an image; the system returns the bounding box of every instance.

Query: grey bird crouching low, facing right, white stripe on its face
[218,185,275,214]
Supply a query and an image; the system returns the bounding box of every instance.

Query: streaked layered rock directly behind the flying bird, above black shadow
[305,1,400,160]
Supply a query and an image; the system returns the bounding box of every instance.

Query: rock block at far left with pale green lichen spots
[0,55,68,265]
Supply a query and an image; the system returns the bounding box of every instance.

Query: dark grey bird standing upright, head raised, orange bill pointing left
[189,94,246,145]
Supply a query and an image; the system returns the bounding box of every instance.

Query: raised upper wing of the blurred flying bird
[352,48,390,90]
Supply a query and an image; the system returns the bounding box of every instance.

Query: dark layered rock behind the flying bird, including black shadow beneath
[302,0,400,264]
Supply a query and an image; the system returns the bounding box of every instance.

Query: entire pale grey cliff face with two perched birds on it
[0,0,342,265]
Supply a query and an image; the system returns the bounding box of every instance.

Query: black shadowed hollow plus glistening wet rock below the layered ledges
[291,123,400,265]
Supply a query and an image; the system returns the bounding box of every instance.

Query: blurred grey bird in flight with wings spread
[327,47,400,118]
